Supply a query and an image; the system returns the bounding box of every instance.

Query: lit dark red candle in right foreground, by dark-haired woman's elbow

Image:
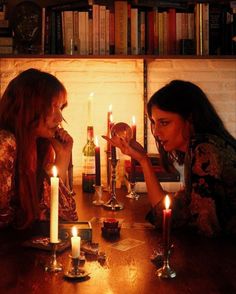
[163,195,171,251]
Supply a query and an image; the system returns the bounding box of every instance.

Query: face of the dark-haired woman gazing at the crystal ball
[150,106,191,152]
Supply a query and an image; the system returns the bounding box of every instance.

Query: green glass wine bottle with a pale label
[82,126,95,193]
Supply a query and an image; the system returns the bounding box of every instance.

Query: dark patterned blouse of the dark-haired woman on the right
[147,134,236,236]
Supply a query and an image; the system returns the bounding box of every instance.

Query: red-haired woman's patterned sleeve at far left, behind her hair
[0,130,16,227]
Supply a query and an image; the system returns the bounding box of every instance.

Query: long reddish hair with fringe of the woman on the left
[0,68,66,228]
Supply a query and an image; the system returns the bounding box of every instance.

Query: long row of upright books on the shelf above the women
[42,1,236,55]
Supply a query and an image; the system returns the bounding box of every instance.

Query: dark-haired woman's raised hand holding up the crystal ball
[102,136,147,163]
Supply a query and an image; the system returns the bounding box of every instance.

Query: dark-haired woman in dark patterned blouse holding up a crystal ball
[105,80,236,236]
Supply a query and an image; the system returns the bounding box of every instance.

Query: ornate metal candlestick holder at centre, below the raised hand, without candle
[103,158,124,210]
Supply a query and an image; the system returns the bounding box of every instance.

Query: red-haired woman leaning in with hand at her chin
[0,69,77,229]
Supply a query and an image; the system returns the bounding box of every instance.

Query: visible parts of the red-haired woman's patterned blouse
[0,130,78,228]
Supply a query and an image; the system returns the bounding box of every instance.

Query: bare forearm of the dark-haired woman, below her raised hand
[140,157,165,206]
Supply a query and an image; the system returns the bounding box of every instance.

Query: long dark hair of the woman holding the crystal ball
[147,80,236,170]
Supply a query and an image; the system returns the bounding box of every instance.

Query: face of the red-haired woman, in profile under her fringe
[36,95,67,138]
